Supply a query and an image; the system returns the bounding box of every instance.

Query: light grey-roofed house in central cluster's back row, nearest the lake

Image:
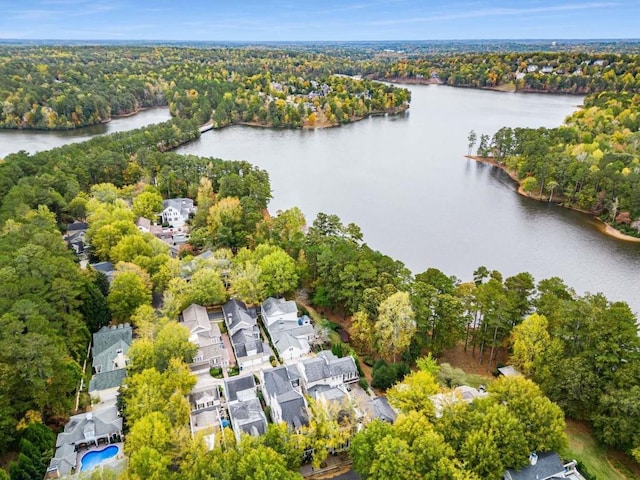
[261,297,315,360]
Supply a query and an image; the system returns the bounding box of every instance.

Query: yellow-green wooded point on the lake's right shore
[470,92,640,237]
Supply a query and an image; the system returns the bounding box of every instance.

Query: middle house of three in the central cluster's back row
[222,299,271,370]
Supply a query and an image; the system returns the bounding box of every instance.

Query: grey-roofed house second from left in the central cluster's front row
[224,375,267,441]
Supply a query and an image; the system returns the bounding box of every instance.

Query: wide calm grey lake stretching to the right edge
[178,86,640,313]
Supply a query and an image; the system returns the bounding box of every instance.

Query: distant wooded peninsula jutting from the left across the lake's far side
[0,46,411,130]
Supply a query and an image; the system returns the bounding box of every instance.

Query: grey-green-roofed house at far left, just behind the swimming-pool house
[89,323,132,405]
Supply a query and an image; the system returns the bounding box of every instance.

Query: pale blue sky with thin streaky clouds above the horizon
[0,0,640,41]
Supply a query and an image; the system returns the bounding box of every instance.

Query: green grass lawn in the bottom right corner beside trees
[562,420,640,480]
